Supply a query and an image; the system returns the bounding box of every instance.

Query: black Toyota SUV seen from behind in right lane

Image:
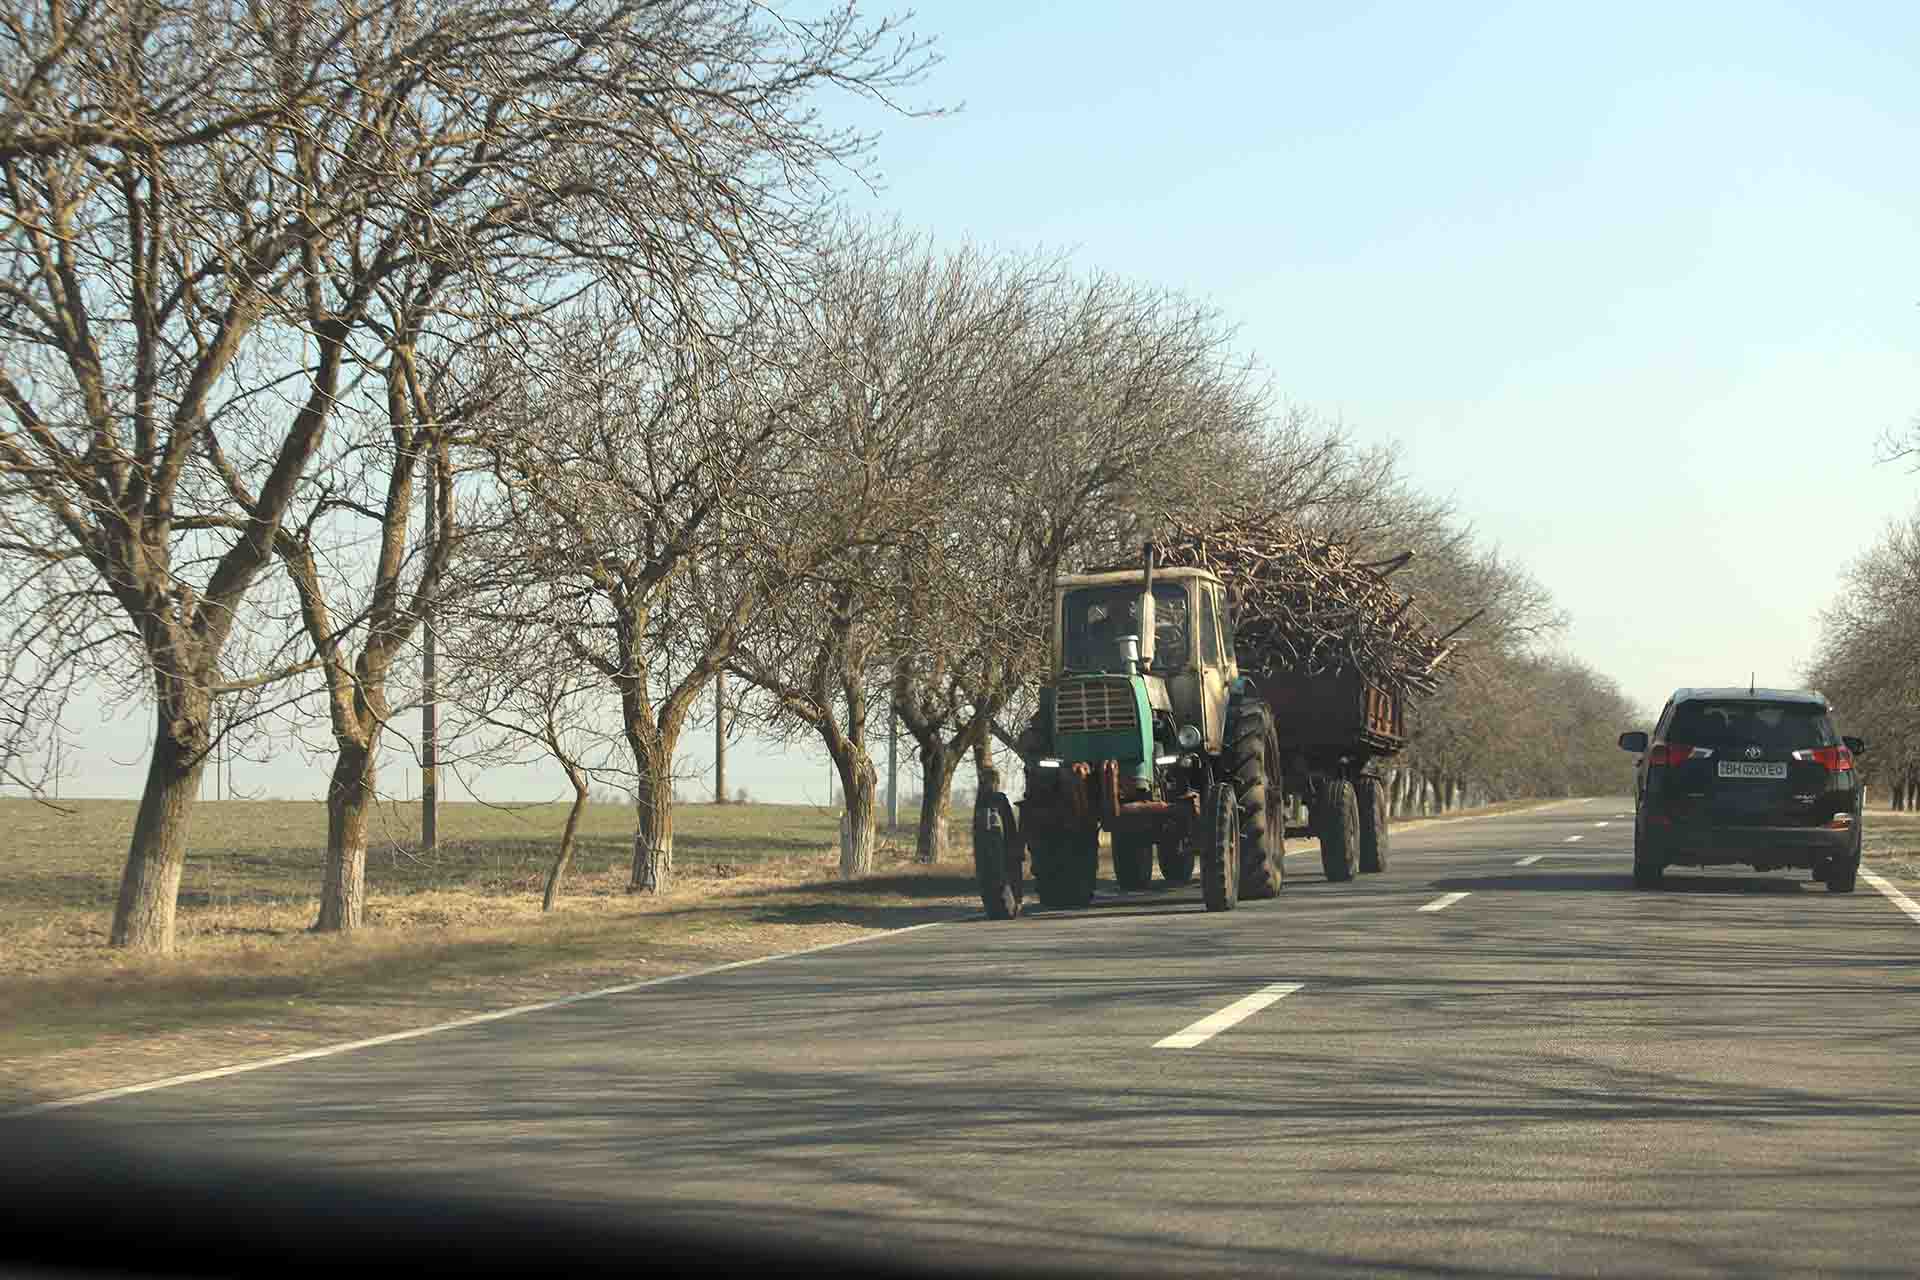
[1620,689,1866,894]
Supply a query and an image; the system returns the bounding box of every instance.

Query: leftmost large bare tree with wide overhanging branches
[0,0,927,950]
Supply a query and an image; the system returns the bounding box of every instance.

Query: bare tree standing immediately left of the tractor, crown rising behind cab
[893,266,1267,860]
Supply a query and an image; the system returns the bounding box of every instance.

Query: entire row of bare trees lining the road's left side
[0,0,1635,950]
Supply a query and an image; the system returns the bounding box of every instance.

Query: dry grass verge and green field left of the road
[0,798,977,1105]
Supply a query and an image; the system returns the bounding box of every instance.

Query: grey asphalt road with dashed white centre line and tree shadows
[0,800,1920,1276]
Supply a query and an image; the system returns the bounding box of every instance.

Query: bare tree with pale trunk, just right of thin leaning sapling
[470,313,833,892]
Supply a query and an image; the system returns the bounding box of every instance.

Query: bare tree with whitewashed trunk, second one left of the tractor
[732,228,1082,877]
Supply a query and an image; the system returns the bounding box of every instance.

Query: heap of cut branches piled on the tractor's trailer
[1160,518,1478,695]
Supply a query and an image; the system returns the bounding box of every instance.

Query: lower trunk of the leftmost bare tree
[108,721,205,954]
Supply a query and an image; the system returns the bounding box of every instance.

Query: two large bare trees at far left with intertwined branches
[0,0,929,950]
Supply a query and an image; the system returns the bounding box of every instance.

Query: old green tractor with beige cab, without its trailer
[973,543,1286,919]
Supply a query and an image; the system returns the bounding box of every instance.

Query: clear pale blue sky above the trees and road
[33,0,1920,800]
